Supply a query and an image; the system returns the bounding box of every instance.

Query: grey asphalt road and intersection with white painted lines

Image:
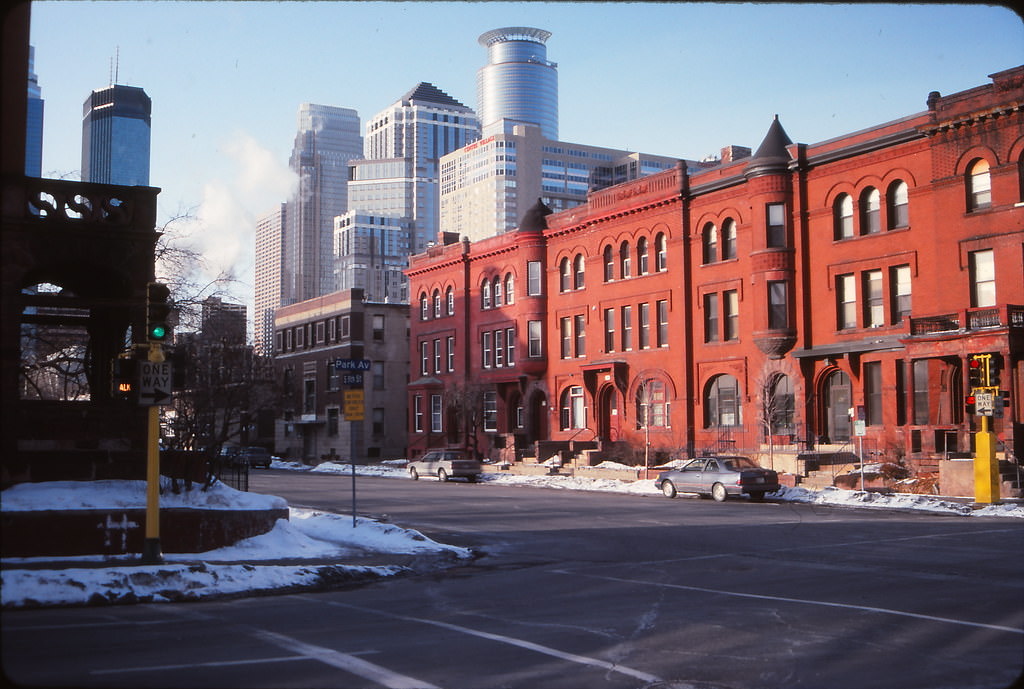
[3,471,1024,689]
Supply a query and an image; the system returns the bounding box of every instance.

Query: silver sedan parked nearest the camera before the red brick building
[654,457,778,503]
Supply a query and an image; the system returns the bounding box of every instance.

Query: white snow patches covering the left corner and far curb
[0,460,1024,608]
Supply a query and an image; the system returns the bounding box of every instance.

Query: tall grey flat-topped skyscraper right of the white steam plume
[282,103,362,304]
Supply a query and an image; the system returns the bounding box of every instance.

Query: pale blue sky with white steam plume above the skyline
[25,0,1024,313]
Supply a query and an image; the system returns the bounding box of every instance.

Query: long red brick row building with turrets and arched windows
[408,67,1024,479]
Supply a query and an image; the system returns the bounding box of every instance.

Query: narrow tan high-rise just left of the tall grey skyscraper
[253,204,288,356]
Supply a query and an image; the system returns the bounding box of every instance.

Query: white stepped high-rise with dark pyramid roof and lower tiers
[334,82,480,302]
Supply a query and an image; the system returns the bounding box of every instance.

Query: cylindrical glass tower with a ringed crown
[476,27,558,140]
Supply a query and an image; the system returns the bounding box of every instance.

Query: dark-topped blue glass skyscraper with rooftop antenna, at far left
[82,84,153,186]
